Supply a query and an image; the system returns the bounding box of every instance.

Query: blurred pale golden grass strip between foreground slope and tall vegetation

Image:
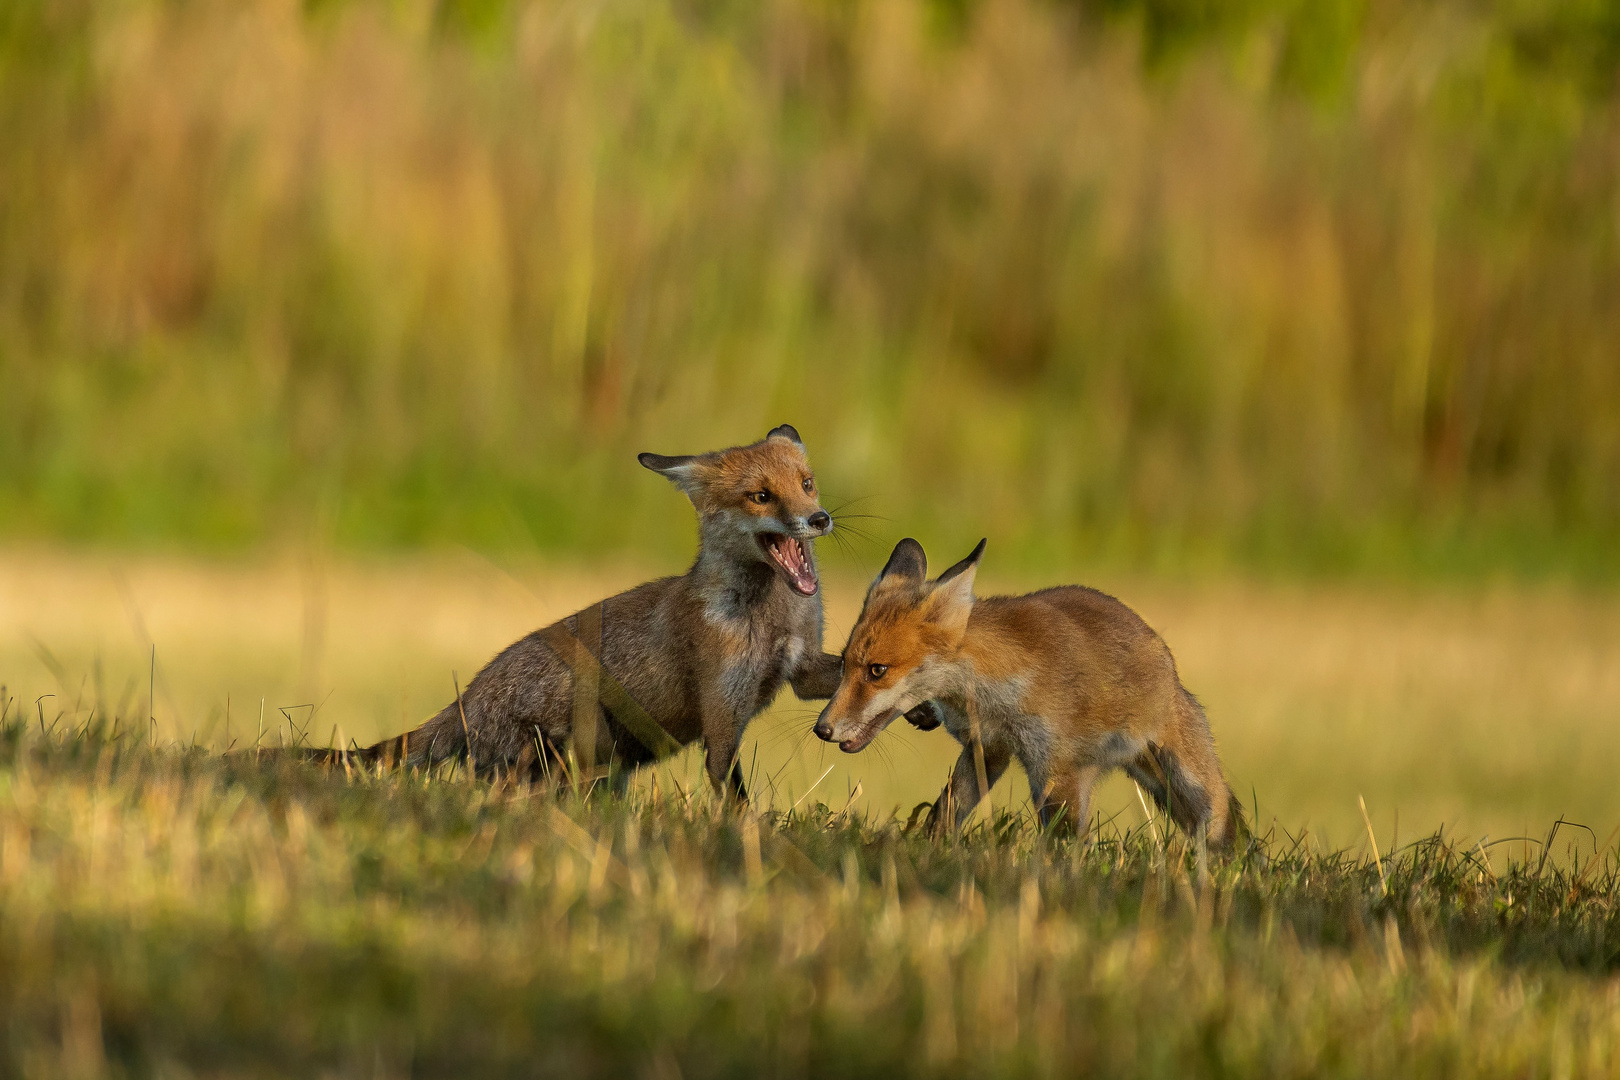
[0,551,1620,852]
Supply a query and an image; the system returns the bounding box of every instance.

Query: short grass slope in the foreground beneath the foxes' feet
[0,712,1620,1077]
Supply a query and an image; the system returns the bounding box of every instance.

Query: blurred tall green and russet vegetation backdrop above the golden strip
[0,0,1620,576]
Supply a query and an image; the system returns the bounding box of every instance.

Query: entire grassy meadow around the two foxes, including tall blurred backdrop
[0,0,1620,1080]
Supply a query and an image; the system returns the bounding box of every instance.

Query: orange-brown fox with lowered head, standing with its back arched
[815,539,1243,847]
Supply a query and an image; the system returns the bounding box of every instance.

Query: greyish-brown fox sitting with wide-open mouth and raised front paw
[341,424,839,798]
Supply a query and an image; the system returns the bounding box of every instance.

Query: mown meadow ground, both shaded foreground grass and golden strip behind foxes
[0,549,1620,1078]
